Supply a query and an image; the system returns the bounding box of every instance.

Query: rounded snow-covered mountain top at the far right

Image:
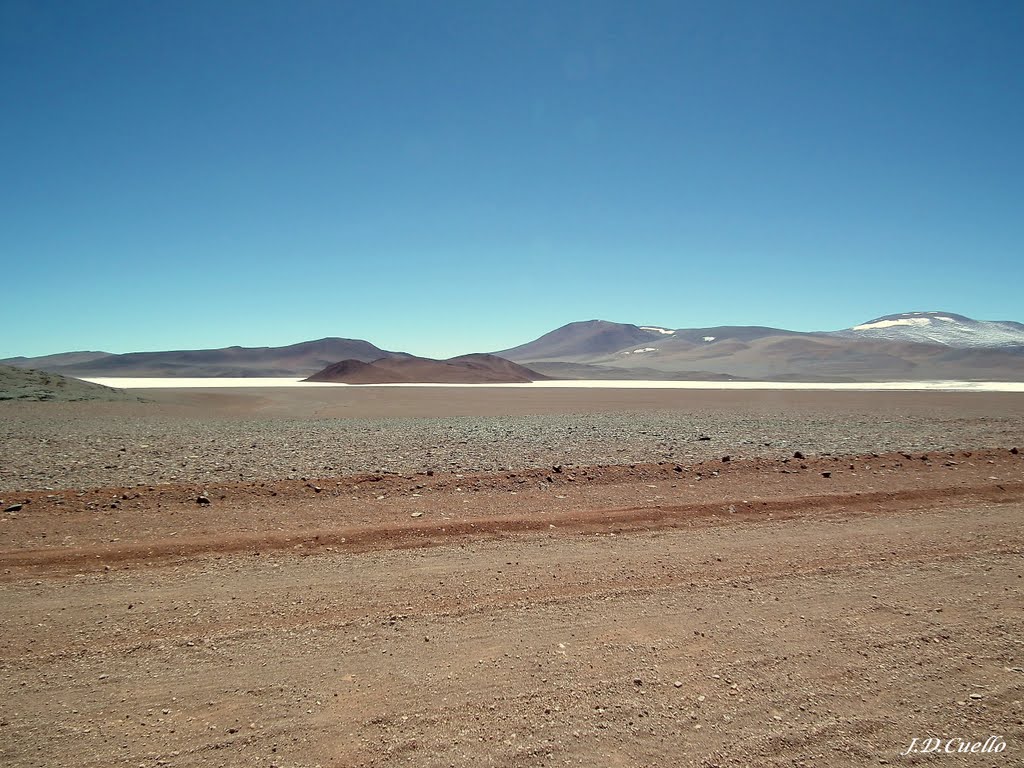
[836,311,1024,347]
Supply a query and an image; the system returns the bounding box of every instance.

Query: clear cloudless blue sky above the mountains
[0,0,1024,357]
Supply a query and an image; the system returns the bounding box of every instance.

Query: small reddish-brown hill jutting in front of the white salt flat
[305,354,549,384]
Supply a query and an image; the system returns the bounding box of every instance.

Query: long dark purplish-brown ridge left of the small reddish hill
[3,338,395,377]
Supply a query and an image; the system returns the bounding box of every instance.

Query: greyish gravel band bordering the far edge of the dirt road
[0,403,1024,490]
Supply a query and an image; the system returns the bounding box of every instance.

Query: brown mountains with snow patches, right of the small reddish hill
[496,312,1024,381]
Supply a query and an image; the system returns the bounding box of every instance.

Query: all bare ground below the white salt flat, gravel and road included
[0,386,1024,768]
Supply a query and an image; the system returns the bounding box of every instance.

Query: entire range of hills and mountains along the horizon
[0,311,1024,383]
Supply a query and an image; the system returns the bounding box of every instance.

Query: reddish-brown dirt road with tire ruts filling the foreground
[0,451,1024,768]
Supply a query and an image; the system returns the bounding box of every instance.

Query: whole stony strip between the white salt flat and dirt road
[0,388,1024,490]
